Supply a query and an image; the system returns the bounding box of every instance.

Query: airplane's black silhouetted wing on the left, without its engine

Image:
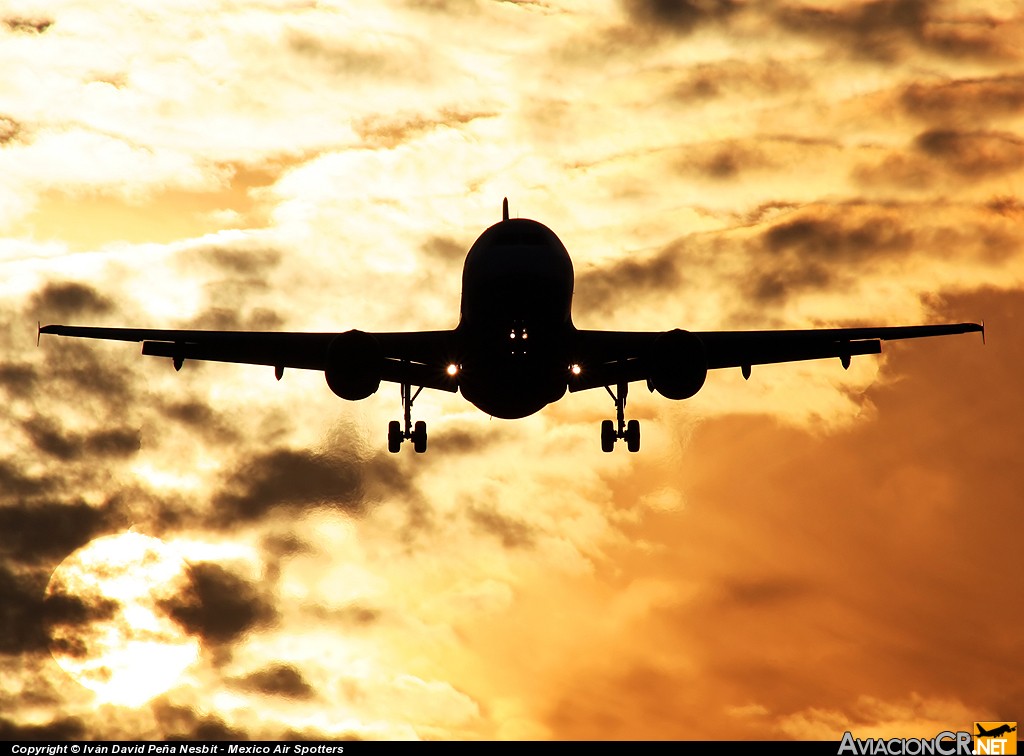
[39,326,456,391]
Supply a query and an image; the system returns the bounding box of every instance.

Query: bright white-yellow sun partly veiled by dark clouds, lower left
[46,531,199,706]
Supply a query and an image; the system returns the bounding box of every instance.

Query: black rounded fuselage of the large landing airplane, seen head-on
[457,218,575,418]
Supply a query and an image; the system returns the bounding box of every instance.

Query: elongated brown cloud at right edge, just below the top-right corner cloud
[900,75,1024,126]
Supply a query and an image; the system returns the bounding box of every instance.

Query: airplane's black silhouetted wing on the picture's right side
[569,323,984,391]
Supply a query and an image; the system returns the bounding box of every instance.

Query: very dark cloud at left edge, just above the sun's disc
[0,501,121,563]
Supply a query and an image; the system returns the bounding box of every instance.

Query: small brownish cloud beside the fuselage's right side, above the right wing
[572,245,683,314]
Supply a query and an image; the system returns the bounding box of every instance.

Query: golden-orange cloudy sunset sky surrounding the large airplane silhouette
[0,0,1024,740]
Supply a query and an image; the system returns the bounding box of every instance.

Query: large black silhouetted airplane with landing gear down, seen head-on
[37,198,984,453]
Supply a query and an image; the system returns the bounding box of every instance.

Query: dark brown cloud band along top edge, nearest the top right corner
[776,0,1019,61]
